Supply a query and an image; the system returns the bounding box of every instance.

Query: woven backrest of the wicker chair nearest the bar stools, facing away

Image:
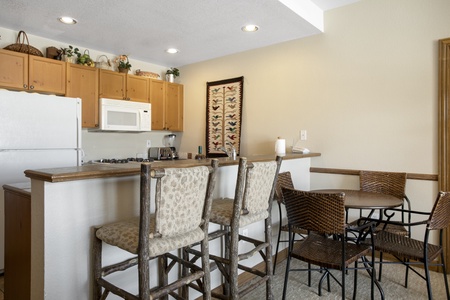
[282,187,345,234]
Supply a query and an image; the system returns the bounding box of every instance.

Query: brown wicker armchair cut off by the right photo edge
[375,192,450,300]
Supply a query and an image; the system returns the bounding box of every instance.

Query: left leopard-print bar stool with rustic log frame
[93,160,218,300]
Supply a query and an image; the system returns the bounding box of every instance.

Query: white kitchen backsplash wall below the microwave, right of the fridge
[81,129,182,162]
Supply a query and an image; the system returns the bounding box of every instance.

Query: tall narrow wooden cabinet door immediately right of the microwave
[149,79,165,130]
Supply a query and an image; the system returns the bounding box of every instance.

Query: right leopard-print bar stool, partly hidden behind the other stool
[210,157,282,300]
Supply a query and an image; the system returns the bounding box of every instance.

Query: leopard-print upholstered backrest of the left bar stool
[155,166,209,237]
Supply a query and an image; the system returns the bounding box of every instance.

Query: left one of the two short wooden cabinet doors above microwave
[99,70,127,100]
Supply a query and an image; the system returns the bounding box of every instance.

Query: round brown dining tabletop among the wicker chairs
[312,189,403,209]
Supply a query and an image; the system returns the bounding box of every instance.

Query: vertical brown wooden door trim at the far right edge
[438,38,450,273]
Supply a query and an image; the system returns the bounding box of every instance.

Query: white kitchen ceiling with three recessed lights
[0,0,359,67]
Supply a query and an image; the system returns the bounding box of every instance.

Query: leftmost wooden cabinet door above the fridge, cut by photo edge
[0,49,28,90]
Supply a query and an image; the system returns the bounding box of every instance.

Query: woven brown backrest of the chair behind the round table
[359,171,406,199]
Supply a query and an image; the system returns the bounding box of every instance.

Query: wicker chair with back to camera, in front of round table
[282,188,376,299]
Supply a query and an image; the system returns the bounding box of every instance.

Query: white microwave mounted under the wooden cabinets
[99,98,152,132]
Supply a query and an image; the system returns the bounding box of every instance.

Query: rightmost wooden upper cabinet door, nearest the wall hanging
[165,82,183,131]
